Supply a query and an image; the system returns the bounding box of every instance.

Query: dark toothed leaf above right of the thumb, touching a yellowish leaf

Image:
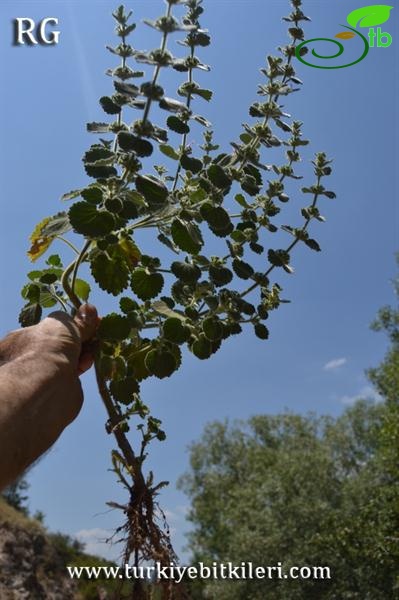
[91,254,130,296]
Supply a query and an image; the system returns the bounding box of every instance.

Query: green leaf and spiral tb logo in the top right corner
[295,4,393,69]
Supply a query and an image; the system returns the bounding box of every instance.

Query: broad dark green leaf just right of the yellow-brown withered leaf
[69,200,115,237]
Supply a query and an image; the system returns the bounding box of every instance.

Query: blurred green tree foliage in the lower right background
[180,270,399,600]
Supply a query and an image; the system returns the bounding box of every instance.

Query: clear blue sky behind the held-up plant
[0,0,399,556]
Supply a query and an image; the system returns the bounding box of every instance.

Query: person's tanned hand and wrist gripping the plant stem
[0,304,99,489]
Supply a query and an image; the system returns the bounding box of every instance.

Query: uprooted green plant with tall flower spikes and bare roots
[20,0,335,596]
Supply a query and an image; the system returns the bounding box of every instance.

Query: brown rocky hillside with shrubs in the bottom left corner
[0,498,117,600]
